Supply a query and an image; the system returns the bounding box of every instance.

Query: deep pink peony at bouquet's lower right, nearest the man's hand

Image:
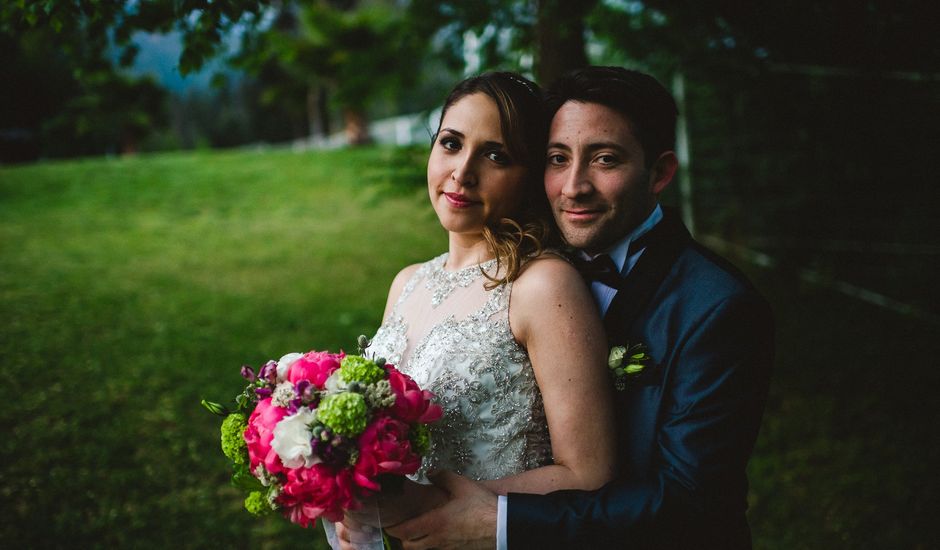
[353,415,421,491]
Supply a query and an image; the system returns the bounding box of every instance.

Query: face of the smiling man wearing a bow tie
[545,101,656,253]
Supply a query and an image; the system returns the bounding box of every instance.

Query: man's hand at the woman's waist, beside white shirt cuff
[386,471,497,550]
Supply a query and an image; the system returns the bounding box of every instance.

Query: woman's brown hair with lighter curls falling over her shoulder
[438,72,560,290]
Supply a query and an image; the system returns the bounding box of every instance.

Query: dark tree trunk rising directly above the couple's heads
[535,0,597,85]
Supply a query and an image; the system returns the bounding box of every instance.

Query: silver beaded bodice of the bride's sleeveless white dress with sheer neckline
[369,254,551,479]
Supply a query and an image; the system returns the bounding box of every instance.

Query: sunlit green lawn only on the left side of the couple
[0,149,446,549]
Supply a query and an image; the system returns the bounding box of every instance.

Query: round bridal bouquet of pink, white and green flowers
[203,337,441,527]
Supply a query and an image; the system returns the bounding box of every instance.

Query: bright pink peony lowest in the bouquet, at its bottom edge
[278,464,360,527]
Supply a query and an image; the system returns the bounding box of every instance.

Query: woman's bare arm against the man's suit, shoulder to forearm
[485,257,616,494]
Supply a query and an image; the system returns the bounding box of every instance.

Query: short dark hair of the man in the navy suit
[545,67,678,168]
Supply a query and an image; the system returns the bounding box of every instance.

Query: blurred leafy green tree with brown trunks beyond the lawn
[236,1,424,145]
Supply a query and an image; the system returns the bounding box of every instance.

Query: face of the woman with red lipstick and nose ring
[428,93,526,239]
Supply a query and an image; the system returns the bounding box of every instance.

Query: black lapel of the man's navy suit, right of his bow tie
[604,207,692,341]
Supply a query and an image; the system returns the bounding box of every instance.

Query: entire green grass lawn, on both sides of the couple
[0,149,940,548]
